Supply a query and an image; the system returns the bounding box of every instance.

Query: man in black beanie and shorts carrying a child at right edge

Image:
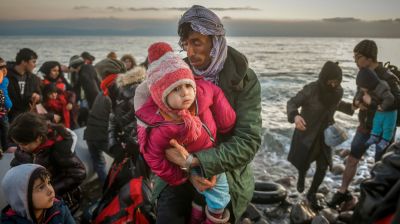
[328,40,400,208]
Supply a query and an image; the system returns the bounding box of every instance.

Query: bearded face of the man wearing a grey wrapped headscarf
[182,32,212,70]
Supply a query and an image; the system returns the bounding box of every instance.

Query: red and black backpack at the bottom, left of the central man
[92,154,155,224]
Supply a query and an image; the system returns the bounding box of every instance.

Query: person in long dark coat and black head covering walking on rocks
[287,61,352,210]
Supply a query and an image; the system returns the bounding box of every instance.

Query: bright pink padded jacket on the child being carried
[136,79,236,185]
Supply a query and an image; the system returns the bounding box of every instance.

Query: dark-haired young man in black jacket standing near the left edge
[7,48,42,122]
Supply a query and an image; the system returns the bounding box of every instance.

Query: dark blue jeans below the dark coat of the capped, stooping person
[86,141,108,183]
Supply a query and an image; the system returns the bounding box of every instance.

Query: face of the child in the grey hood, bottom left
[32,178,55,210]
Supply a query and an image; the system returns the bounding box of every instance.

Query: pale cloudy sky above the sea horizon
[0,0,400,21]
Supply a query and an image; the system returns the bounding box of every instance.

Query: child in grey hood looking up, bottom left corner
[1,164,75,224]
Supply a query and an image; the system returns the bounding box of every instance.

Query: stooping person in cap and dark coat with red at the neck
[84,58,126,183]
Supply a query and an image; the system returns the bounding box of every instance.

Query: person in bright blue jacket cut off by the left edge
[0,58,12,156]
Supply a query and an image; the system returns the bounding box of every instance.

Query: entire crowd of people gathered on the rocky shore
[0,5,400,224]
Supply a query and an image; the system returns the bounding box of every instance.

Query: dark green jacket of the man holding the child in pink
[153,47,262,220]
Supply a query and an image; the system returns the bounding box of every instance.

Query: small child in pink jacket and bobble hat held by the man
[136,43,236,223]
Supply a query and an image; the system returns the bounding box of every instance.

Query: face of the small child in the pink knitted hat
[167,84,195,110]
